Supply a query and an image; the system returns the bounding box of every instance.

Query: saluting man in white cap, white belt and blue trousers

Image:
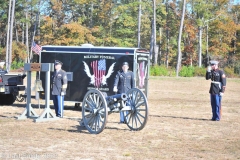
[206,61,226,121]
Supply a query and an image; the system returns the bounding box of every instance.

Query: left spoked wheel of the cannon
[82,89,108,134]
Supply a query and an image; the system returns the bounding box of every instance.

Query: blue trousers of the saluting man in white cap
[210,94,222,121]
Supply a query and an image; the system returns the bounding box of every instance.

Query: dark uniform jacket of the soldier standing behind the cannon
[114,70,135,93]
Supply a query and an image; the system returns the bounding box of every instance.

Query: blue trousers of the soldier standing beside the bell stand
[53,95,64,117]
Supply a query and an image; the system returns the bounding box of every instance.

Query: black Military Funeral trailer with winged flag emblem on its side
[40,46,149,102]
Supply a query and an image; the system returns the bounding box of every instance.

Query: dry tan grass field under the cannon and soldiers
[0,77,240,160]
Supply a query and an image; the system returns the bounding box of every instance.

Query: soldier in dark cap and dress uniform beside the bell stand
[52,60,67,117]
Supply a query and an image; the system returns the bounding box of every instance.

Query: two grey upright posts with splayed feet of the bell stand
[17,63,59,122]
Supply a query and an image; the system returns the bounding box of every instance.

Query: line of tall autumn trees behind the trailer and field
[0,0,240,73]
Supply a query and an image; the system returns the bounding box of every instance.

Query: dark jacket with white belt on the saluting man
[206,69,226,94]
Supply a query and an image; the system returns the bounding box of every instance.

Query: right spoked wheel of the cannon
[124,88,148,131]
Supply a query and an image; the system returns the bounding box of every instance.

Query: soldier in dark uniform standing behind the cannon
[113,62,135,123]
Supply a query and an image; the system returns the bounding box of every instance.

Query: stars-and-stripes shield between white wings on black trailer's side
[91,59,106,88]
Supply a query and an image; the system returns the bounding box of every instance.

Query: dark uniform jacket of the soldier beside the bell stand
[52,69,67,95]
